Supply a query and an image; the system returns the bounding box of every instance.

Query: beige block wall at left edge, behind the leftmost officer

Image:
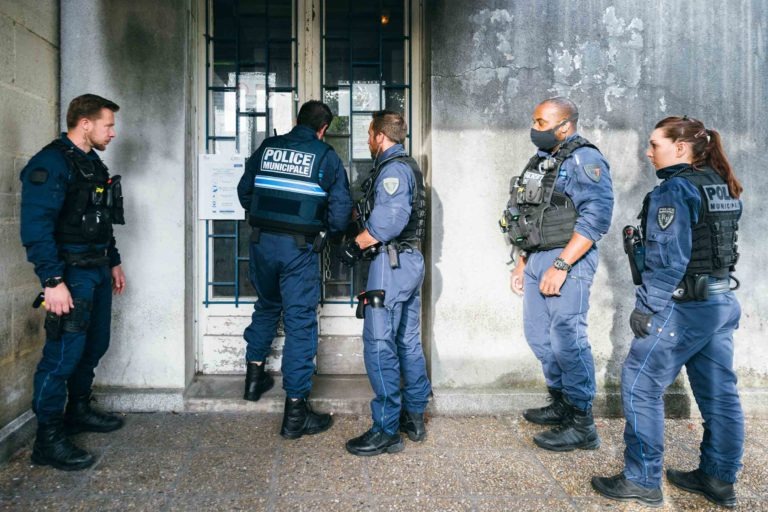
[0,0,59,430]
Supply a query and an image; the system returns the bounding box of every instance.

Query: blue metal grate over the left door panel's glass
[204,0,298,306]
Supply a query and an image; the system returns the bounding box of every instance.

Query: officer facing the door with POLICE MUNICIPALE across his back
[237,101,352,439]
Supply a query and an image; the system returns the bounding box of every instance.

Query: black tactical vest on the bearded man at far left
[45,139,125,244]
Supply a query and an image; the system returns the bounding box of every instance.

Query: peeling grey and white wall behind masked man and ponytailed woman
[429,0,768,400]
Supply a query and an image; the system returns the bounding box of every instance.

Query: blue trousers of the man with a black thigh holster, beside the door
[363,251,432,434]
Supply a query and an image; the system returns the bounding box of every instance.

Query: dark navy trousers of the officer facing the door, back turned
[243,232,320,398]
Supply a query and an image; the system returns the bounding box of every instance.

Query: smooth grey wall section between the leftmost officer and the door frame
[61,0,191,392]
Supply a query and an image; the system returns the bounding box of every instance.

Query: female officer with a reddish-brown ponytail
[592,117,744,507]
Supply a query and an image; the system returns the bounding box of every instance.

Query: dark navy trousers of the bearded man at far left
[32,265,112,423]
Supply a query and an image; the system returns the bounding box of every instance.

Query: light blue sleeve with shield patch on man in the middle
[366,162,415,243]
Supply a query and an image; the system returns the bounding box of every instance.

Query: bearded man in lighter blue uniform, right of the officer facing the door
[340,110,431,455]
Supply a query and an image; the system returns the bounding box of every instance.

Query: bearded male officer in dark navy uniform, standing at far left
[20,94,125,470]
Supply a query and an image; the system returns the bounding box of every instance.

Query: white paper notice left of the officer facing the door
[197,154,245,220]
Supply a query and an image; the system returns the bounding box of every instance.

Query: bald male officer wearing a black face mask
[502,97,613,451]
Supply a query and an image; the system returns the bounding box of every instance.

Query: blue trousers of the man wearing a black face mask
[523,249,597,410]
